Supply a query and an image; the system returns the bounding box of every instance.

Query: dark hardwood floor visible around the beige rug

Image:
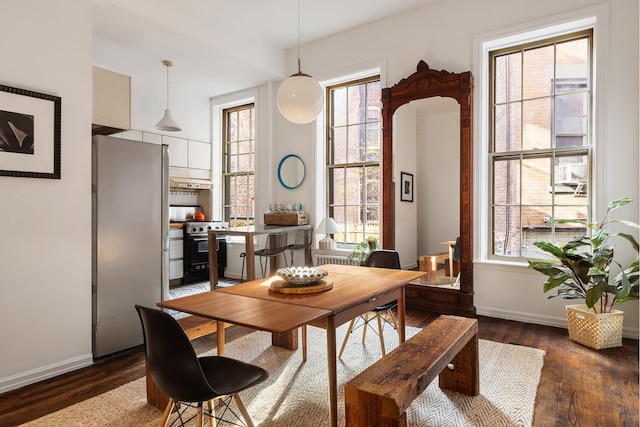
[0,310,640,427]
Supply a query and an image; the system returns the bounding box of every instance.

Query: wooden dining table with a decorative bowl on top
[158,265,424,426]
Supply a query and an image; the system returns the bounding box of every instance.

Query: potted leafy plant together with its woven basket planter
[529,198,640,349]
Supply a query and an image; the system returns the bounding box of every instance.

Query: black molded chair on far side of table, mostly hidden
[338,249,400,358]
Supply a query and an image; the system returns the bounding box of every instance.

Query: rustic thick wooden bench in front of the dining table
[344,315,480,427]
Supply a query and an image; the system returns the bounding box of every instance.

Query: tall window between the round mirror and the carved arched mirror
[326,76,382,244]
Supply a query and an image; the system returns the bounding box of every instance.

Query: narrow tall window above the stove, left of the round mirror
[223,104,255,226]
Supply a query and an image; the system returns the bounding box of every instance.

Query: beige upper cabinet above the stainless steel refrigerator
[91,67,131,135]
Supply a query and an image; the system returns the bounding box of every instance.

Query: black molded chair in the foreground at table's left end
[136,305,269,426]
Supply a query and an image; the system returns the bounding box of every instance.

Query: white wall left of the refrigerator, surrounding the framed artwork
[0,0,92,392]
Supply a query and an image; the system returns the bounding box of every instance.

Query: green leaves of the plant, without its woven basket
[529,198,640,313]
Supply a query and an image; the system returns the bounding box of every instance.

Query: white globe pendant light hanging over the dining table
[277,0,324,124]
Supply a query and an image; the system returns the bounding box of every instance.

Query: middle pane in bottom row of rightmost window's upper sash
[522,98,551,150]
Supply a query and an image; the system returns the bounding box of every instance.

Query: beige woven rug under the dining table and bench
[24,325,544,427]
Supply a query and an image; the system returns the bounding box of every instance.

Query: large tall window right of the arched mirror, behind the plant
[489,30,593,259]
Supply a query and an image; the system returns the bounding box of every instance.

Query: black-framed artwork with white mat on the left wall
[0,85,62,179]
